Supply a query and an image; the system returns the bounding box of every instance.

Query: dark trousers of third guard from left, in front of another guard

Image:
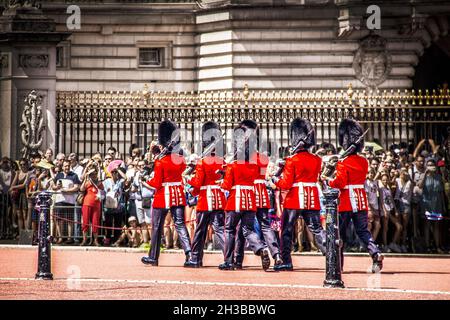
[224,211,266,264]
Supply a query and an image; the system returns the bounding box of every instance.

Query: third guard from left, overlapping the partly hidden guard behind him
[219,126,270,270]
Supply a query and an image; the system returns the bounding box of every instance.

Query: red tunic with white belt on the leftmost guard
[147,153,186,209]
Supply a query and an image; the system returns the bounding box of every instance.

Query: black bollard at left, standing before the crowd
[35,192,53,280]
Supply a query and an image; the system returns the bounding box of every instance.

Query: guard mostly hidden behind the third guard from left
[235,120,283,269]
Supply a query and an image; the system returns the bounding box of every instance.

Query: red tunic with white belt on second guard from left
[188,156,226,212]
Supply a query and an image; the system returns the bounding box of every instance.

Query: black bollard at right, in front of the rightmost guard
[323,188,345,288]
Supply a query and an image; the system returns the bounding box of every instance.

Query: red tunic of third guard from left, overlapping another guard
[221,161,259,212]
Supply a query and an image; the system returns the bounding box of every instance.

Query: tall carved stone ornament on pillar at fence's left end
[20,90,45,158]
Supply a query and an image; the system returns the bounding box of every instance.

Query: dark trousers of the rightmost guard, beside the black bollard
[339,211,380,266]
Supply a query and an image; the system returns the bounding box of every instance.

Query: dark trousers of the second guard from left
[191,211,225,263]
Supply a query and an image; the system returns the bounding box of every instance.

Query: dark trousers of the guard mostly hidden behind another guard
[235,208,280,263]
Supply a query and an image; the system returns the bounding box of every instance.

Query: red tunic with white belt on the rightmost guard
[329,154,369,212]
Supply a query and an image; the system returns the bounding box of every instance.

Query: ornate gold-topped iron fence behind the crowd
[56,86,450,160]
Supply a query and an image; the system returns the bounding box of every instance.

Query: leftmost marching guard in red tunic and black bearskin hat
[142,120,191,266]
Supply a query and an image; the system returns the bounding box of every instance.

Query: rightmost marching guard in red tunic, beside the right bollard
[328,119,383,273]
